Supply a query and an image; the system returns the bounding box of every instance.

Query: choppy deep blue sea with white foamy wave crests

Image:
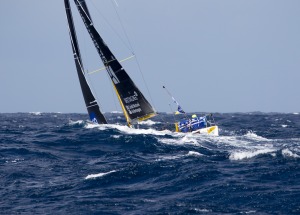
[0,112,300,214]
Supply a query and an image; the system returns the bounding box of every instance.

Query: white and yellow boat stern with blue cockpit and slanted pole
[163,86,219,136]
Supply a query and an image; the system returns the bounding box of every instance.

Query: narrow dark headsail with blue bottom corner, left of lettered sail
[64,0,107,124]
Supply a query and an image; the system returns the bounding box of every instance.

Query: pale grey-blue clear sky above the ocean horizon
[0,0,300,113]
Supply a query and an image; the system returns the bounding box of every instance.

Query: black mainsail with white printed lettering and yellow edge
[74,0,156,125]
